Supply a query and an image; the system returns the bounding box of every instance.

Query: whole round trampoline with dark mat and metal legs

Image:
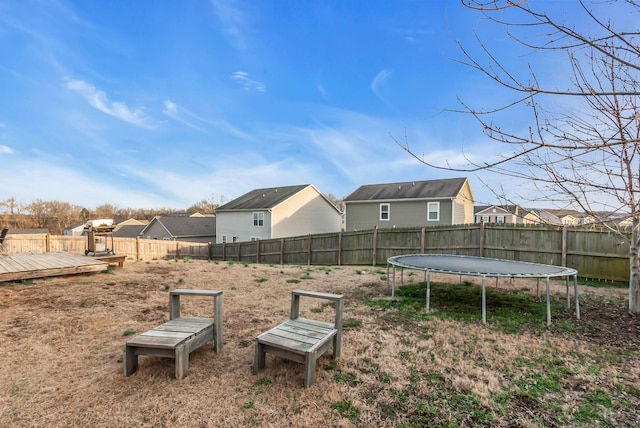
[387,254,580,325]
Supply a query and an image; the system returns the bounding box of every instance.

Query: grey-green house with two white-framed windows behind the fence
[344,178,474,231]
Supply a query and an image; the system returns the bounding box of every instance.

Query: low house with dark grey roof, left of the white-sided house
[140,215,216,242]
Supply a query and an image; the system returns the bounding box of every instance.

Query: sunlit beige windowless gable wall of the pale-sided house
[271,187,342,238]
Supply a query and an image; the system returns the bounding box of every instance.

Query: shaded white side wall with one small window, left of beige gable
[216,209,275,244]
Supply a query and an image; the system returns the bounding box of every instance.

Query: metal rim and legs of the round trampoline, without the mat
[387,254,580,325]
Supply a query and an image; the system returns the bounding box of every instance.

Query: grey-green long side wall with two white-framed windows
[346,199,456,231]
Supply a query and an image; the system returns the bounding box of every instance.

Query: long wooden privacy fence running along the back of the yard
[0,223,629,282]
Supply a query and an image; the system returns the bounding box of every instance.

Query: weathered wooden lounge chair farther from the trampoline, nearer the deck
[124,289,223,379]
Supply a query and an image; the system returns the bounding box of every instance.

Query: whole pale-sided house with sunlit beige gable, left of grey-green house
[216,184,341,243]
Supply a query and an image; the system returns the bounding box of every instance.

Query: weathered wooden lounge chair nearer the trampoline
[253,290,344,388]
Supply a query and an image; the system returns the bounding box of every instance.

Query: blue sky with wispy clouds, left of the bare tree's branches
[0,0,624,209]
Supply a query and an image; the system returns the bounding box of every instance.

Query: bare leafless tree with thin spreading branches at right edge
[396,0,640,313]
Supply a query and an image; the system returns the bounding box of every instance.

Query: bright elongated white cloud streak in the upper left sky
[67,80,152,128]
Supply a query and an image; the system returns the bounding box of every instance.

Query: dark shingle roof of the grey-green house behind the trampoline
[344,178,467,202]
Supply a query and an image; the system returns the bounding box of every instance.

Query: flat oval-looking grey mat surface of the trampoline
[387,254,577,278]
